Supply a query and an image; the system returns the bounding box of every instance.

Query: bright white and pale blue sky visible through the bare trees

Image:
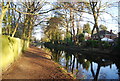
[10,0,119,39]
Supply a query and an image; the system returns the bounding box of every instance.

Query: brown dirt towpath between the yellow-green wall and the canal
[2,47,73,79]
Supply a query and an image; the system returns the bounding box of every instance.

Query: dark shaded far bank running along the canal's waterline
[43,43,120,57]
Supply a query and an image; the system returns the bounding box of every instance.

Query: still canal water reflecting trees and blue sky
[38,45,120,79]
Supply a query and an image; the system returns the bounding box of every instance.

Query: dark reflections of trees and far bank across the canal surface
[45,45,120,80]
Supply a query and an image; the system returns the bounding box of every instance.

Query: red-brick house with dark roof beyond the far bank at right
[93,30,117,39]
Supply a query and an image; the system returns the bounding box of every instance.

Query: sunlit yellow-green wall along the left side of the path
[0,36,29,71]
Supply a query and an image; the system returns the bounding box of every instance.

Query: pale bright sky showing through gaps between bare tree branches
[34,0,119,39]
